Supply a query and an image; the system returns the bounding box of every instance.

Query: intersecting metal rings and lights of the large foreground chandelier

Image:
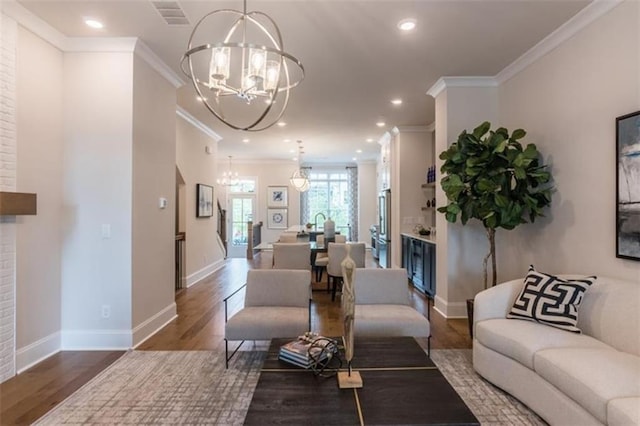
[180,0,305,132]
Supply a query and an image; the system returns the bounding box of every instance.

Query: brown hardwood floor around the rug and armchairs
[0,253,471,425]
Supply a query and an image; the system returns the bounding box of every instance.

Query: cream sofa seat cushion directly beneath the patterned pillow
[475,318,614,370]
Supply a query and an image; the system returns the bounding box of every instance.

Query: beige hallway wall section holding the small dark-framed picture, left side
[174,112,224,285]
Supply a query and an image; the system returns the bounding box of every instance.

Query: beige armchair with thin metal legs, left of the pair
[224,269,311,367]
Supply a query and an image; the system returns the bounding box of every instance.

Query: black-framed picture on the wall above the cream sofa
[616,111,640,260]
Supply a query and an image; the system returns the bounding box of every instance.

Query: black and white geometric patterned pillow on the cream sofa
[507,265,596,333]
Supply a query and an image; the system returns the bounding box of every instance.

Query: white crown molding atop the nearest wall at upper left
[0,0,184,88]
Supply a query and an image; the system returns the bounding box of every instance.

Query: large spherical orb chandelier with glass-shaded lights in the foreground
[180,0,304,131]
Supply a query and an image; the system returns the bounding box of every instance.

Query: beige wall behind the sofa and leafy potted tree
[497,0,640,282]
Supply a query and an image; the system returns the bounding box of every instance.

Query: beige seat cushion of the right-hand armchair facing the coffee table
[353,305,430,337]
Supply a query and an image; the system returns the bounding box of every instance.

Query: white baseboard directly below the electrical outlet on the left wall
[61,330,132,351]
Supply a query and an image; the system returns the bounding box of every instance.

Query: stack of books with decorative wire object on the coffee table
[278,333,335,368]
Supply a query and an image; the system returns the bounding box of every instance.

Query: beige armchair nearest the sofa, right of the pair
[353,268,431,356]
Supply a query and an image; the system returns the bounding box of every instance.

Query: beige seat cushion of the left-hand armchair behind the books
[225,306,309,340]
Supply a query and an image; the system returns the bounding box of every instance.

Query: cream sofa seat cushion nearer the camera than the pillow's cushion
[533,348,640,424]
